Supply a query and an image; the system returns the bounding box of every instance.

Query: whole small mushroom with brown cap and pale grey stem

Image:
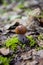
[15,25,28,43]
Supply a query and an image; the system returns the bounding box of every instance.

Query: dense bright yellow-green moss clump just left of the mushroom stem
[5,37,19,50]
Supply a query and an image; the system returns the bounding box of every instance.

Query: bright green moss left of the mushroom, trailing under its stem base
[5,37,25,51]
